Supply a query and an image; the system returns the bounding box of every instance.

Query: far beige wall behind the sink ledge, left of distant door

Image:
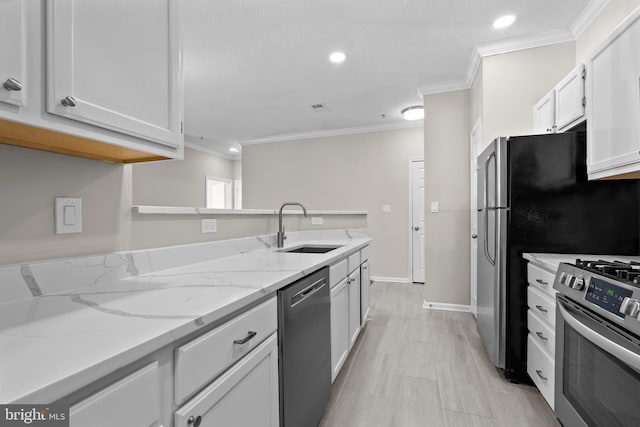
[242,128,424,280]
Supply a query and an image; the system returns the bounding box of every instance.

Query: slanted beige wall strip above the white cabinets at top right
[575,0,640,63]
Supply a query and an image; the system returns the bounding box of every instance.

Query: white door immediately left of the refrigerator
[469,120,482,317]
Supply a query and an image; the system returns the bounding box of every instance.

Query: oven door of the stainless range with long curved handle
[555,295,640,427]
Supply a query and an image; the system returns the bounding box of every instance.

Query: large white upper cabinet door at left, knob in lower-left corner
[46,0,182,147]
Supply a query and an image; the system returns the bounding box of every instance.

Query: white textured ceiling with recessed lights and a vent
[181,0,589,152]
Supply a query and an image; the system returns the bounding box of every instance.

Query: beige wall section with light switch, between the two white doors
[424,90,471,305]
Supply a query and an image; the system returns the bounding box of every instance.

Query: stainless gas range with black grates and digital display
[553,259,640,427]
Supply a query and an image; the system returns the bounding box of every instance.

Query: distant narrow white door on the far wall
[411,160,426,283]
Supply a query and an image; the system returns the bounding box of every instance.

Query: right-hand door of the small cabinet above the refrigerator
[555,64,585,130]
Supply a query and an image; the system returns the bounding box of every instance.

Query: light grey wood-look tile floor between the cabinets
[320,282,560,427]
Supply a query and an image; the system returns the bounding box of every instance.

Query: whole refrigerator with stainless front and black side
[477,132,640,382]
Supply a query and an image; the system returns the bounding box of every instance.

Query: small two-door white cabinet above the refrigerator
[533,64,585,134]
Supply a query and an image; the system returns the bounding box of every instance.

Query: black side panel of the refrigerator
[505,132,640,381]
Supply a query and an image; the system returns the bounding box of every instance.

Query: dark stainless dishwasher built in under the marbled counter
[278,267,331,427]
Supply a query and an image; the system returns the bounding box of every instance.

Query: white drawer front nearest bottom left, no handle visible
[69,362,162,427]
